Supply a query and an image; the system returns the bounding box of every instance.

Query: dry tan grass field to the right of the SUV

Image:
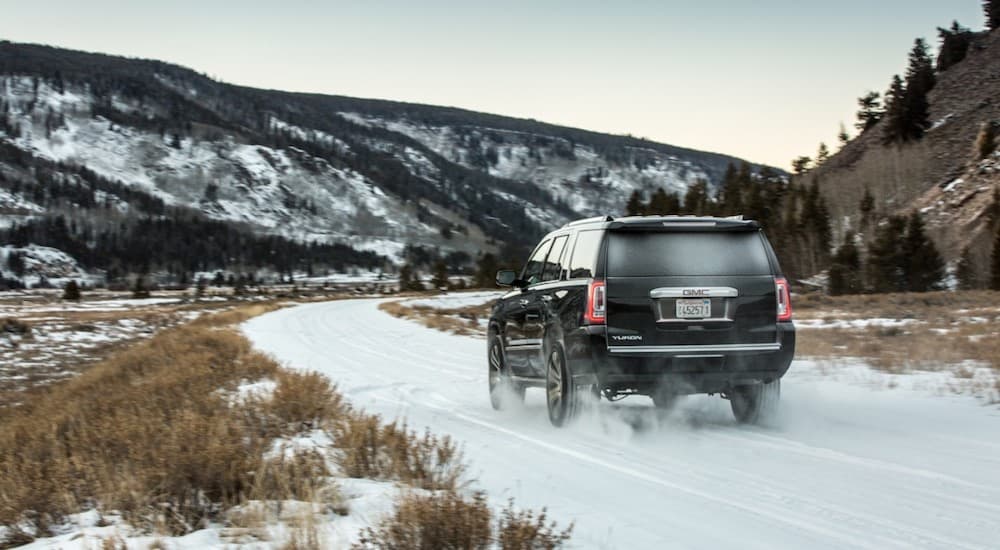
[795,291,1000,372]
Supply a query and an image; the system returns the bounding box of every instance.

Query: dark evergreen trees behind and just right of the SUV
[625,165,972,294]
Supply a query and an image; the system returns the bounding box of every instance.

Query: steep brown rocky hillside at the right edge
[809,26,1000,276]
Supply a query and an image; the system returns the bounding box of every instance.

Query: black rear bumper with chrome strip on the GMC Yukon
[566,322,795,393]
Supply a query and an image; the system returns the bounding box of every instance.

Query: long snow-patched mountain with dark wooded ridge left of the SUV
[0,42,772,284]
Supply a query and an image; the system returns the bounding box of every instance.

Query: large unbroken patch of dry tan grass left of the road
[0,306,342,544]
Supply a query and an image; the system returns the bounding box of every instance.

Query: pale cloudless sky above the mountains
[0,0,984,169]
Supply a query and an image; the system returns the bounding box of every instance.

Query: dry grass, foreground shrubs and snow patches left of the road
[0,296,568,548]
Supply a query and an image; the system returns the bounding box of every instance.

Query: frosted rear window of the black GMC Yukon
[608,232,771,277]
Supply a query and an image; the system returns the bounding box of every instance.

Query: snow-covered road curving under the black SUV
[244,300,1000,549]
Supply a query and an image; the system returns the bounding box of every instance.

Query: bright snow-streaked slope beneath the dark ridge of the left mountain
[0,77,437,264]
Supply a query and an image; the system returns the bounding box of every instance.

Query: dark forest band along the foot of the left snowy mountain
[0,142,387,281]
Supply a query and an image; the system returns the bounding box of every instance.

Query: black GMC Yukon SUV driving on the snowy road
[488,216,795,426]
